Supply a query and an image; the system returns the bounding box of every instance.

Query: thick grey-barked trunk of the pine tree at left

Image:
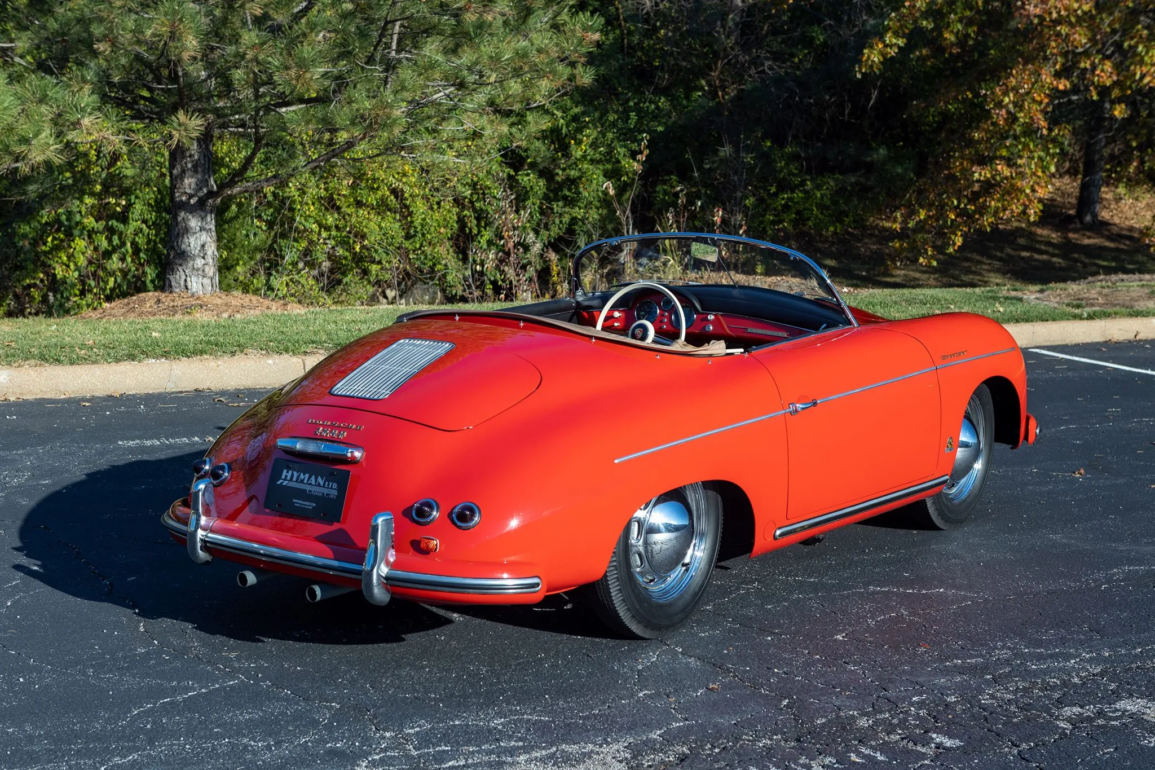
[164,132,219,294]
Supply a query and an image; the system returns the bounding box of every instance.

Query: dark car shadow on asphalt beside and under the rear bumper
[13,453,623,644]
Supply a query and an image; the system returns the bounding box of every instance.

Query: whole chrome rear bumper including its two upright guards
[161,507,542,604]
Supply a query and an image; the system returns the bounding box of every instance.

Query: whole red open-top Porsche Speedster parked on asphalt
[163,233,1037,637]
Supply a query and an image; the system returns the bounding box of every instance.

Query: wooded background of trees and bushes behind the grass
[0,0,1155,315]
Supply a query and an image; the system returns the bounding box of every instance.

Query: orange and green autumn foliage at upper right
[860,0,1155,260]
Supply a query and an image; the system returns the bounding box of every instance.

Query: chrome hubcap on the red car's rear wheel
[628,484,706,601]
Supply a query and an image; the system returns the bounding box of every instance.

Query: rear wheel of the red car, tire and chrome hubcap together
[591,484,722,638]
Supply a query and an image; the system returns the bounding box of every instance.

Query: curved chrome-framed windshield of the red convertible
[573,233,842,306]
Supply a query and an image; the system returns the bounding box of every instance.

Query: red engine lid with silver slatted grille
[283,321,542,431]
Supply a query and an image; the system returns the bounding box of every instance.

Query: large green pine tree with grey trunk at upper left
[0,0,596,294]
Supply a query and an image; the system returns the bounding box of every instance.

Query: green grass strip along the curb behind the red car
[0,289,1155,366]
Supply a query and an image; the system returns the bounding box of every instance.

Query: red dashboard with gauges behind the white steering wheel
[579,290,807,346]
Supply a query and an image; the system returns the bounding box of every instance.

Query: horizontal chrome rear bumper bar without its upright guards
[161,511,542,595]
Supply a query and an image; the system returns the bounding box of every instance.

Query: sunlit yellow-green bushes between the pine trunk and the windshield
[219,144,575,305]
